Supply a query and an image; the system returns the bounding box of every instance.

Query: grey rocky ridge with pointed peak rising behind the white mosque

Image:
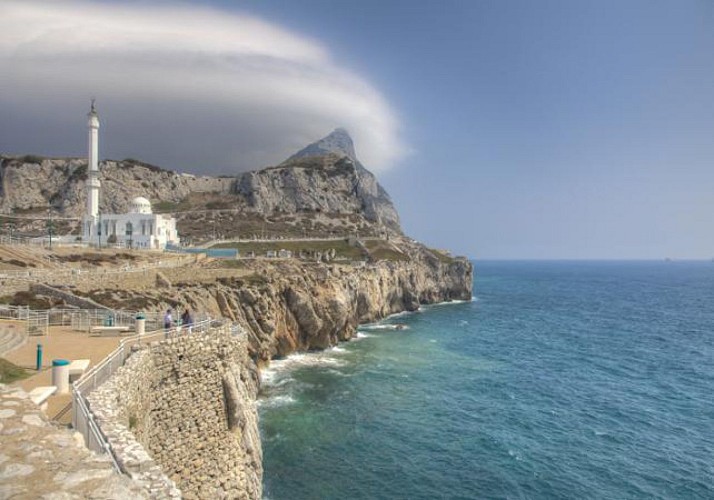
[0,129,400,236]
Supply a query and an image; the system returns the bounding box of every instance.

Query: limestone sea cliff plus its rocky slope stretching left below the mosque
[73,244,473,362]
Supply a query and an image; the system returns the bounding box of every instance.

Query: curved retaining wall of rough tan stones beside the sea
[89,328,262,499]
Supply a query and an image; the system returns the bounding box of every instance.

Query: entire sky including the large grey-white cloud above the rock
[0,0,714,259]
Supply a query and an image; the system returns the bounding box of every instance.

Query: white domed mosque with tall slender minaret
[82,100,179,250]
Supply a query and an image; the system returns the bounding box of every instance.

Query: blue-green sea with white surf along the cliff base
[259,262,714,500]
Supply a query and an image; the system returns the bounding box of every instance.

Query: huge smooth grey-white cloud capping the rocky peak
[0,0,404,173]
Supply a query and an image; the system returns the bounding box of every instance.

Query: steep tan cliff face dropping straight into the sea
[229,260,472,360]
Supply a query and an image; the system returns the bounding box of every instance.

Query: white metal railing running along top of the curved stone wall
[72,319,219,473]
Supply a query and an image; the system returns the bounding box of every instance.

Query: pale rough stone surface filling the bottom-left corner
[0,384,146,500]
